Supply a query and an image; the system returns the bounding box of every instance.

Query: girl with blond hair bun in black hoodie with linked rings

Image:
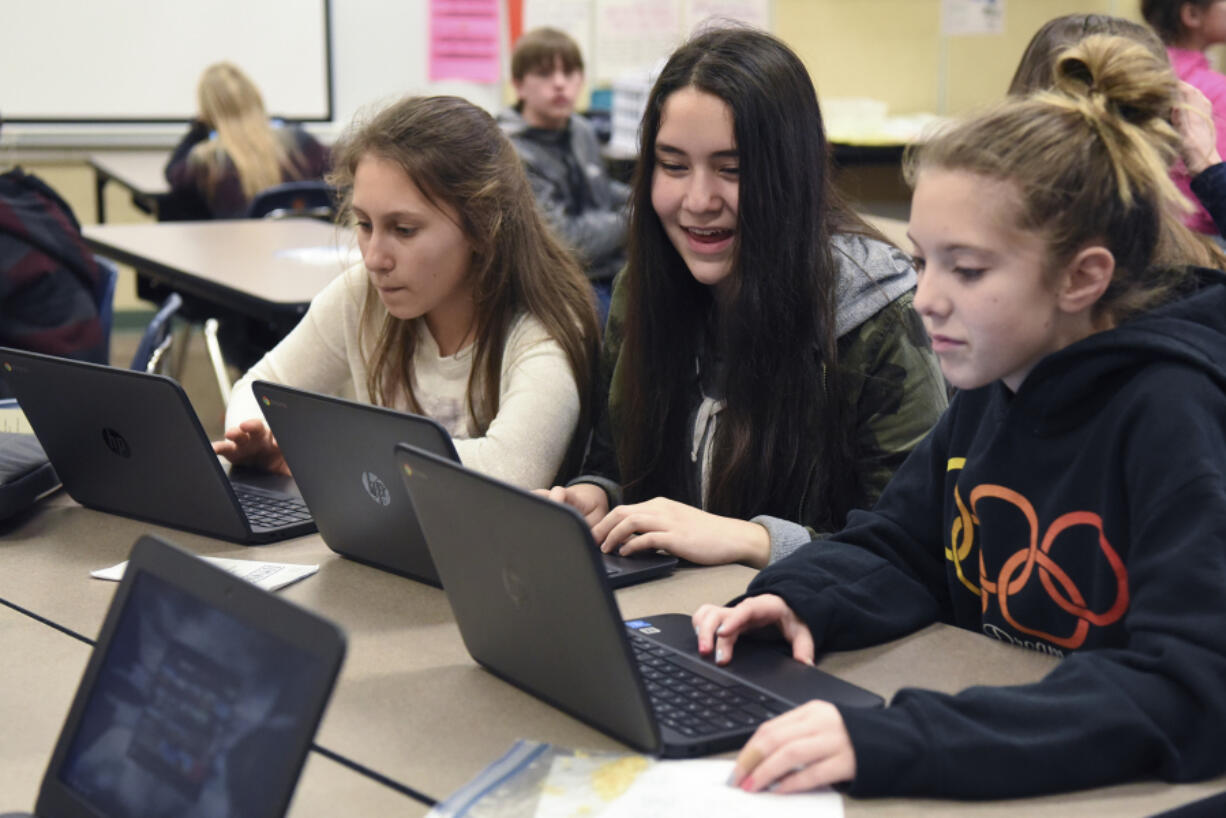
[694,36,1226,798]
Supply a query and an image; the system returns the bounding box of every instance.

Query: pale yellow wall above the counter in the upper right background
[774,0,1140,114]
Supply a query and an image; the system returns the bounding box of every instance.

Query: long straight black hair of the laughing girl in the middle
[614,28,867,525]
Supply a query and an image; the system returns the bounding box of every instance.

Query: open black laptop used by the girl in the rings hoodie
[396,445,883,758]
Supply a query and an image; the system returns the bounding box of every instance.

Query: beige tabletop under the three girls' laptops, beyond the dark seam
[0,495,1226,818]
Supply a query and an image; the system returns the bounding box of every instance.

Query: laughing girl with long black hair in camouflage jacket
[550,28,945,567]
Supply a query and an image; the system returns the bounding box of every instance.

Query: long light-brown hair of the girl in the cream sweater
[330,97,600,456]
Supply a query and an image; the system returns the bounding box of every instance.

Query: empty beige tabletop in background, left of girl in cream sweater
[82,218,360,318]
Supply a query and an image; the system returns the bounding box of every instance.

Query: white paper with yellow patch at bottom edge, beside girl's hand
[536,755,843,818]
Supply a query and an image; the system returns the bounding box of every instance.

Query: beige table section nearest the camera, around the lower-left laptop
[0,606,427,818]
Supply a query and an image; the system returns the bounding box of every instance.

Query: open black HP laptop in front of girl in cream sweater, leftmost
[0,347,315,545]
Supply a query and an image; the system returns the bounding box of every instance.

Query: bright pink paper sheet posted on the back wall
[430,0,499,82]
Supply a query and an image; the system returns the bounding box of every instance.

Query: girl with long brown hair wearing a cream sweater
[213,97,597,488]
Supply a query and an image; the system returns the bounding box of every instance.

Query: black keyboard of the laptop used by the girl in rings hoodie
[628,632,793,738]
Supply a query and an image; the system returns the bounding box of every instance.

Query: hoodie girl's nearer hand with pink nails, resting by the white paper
[731,701,856,792]
